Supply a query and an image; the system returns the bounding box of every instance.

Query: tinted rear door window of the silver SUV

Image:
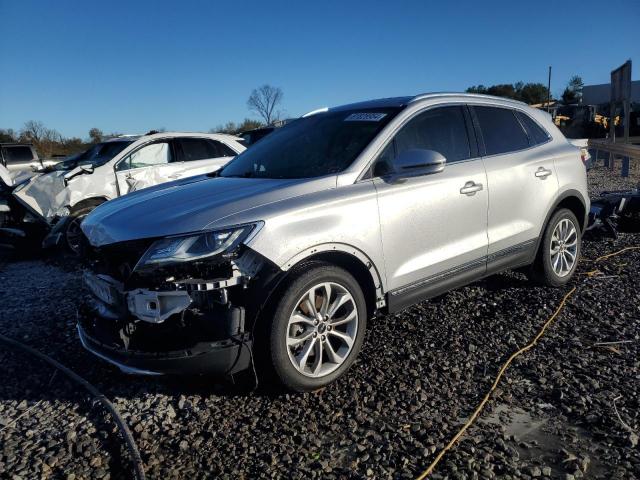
[473,106,529,155]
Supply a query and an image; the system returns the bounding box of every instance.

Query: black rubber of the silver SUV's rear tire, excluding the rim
[531,208,582,287]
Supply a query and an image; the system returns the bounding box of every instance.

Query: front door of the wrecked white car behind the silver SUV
[116,140,173,195]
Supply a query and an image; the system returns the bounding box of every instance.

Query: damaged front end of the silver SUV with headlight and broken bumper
[78,225,279,374]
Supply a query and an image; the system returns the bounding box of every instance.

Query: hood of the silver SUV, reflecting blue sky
[82,175,336,247]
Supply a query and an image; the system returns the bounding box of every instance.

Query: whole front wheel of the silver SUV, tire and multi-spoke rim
[268,264,367,392]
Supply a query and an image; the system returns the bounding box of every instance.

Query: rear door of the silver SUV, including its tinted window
[471,105,558,262]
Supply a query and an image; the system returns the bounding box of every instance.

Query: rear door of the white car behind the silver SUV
[172,138,236,178]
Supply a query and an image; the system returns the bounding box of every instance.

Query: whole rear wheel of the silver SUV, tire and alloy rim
[531,208,582,287]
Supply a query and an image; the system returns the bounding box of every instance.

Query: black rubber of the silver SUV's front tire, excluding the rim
[264,263,368,392]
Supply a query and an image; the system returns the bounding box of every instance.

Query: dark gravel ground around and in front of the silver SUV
[0,168,640,480]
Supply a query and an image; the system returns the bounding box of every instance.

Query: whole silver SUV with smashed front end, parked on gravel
[78,94,589,391]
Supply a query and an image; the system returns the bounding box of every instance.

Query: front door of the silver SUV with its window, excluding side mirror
[373,105,488,309]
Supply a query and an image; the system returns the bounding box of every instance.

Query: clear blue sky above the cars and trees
[0,0,640,137]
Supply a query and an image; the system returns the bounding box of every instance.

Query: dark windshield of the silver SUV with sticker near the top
[220,108,400,178]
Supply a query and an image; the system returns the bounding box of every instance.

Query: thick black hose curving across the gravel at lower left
[0,333,145,480]
